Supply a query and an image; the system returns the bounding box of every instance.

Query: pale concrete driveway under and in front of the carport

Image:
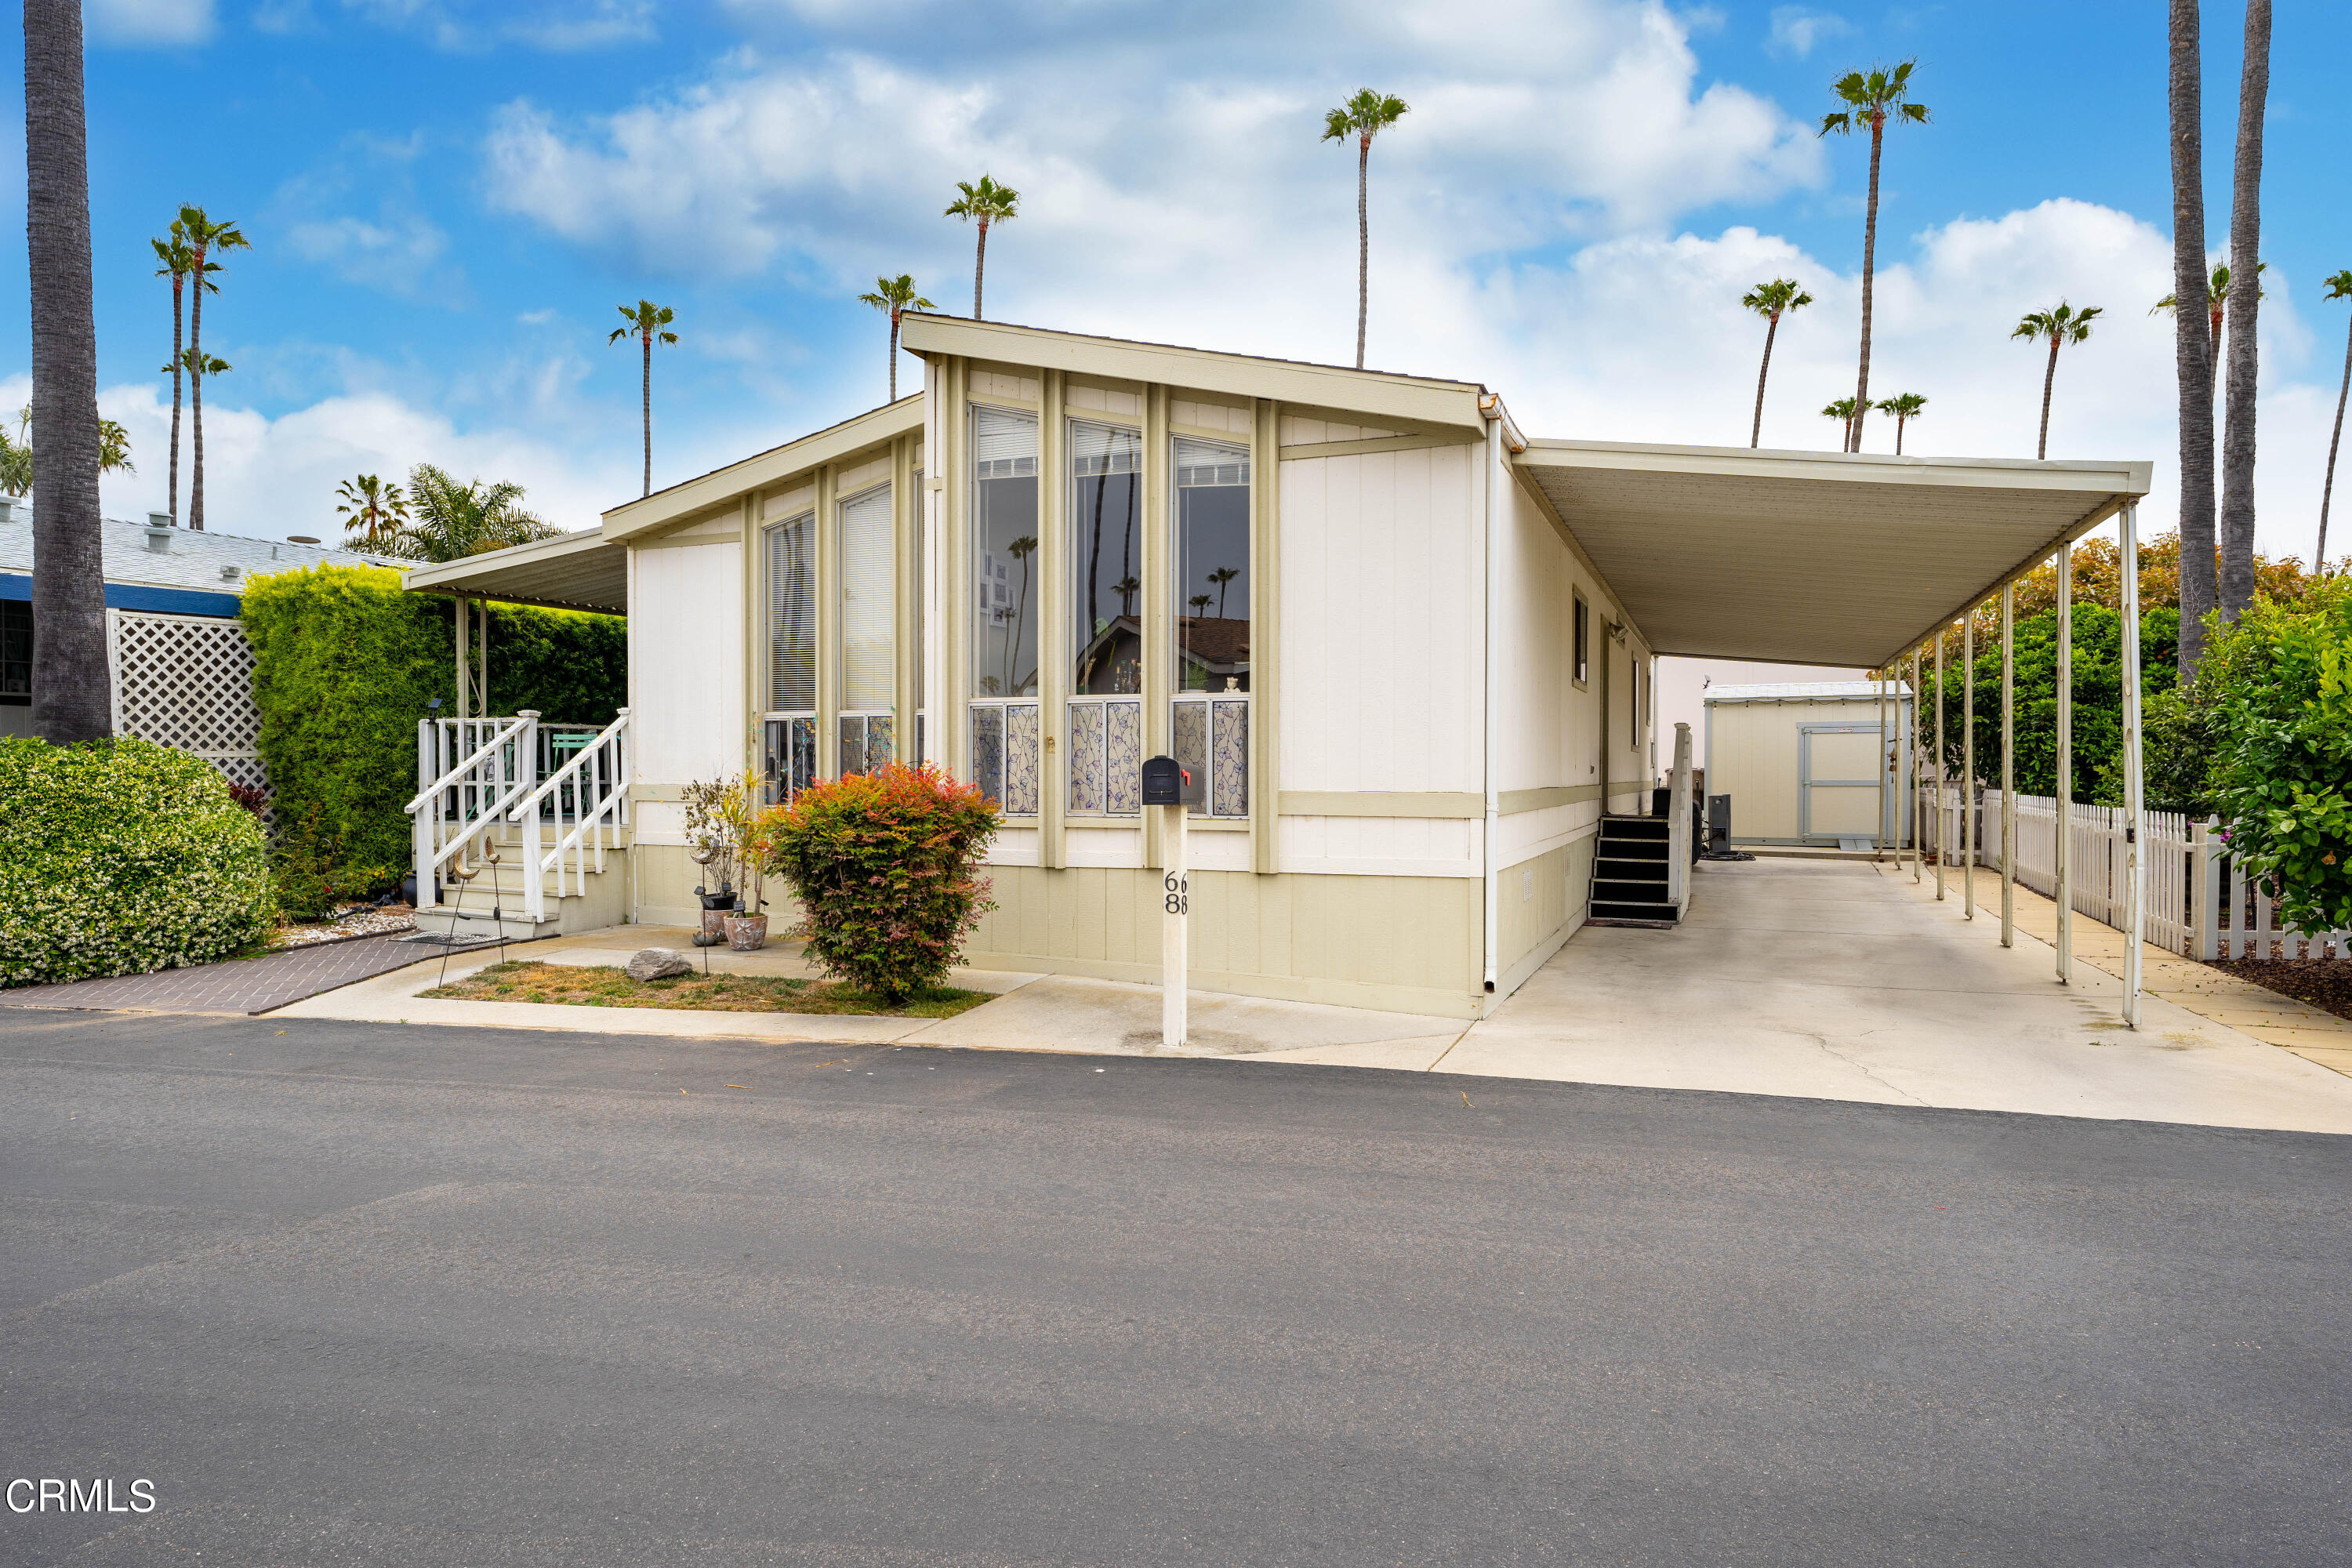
[1432,860,2352,1133]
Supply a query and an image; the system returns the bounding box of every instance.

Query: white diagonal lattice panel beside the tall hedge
[106,609,270,818]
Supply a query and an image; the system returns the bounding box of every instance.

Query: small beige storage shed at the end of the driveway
[1705,682,1912,848]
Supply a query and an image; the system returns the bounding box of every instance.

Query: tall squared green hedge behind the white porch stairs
[242,567,628,884]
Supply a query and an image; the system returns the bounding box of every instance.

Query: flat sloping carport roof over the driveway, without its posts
[1512,440,2150,668]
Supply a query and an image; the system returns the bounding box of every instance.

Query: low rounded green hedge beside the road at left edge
[0,739,273,985]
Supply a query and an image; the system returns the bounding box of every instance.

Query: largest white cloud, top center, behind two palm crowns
[485,0,1823,303]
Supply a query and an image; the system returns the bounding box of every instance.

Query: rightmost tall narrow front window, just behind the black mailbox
[1169,435,1251,815]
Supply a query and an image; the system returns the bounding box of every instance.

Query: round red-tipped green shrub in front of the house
[750,764,997,1006]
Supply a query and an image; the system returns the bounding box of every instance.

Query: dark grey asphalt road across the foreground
[0,1013,2352,1568]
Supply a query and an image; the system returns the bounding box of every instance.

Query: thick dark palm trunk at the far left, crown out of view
[24,0,113,746]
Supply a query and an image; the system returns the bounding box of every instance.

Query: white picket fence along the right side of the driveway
[1922,781,2352,961]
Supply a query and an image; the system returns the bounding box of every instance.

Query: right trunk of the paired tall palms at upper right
[2220,0,2270,621]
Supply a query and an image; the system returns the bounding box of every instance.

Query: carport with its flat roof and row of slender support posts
[1512,440,2150,1027]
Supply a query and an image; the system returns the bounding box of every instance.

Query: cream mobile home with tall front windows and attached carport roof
[407,315,2150,1015]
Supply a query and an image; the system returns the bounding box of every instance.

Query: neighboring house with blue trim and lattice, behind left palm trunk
[0,510,407,785]
